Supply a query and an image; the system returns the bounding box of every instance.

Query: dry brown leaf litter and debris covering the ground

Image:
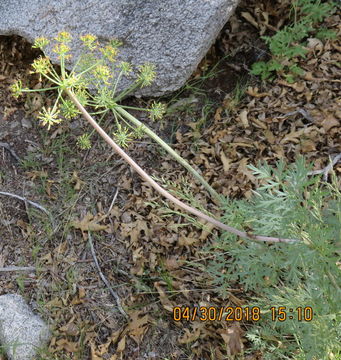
[0,1,341,360]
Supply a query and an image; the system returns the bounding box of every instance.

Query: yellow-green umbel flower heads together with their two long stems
[11,31,296,242]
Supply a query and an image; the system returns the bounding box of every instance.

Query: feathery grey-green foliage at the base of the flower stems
[208,158,341,359]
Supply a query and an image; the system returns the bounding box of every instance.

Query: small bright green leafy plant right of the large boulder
[251,0,336,82]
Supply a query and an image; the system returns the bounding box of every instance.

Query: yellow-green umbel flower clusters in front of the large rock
[10,31,166,149]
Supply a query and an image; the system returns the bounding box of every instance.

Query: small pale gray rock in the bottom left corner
[0,294,50,360]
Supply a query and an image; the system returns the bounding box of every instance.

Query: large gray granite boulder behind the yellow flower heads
[0,0,239,96]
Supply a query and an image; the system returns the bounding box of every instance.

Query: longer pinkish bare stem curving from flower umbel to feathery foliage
[65,89,298,243]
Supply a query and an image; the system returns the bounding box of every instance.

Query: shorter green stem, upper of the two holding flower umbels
[114,106,222,204]
